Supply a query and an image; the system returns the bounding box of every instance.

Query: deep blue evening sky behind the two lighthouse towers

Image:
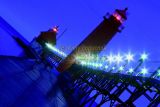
[0,0,160,106]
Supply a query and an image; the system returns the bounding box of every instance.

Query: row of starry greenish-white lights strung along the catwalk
[45,46,155,77]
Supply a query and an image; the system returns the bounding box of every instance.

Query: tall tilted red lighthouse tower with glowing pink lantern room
[57,8,127,72]
